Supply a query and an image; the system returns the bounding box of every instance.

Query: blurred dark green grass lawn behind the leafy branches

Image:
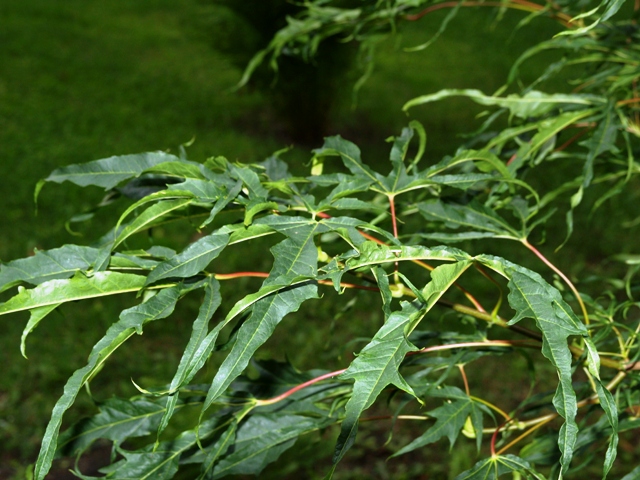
[0,0,600,478]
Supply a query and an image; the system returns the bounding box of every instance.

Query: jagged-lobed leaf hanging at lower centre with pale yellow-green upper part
[333,260,471,463]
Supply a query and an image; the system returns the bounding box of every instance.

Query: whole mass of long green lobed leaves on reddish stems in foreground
[0,0,640,479]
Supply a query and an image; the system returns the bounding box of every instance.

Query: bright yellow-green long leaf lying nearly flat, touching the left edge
[0,272,145,315]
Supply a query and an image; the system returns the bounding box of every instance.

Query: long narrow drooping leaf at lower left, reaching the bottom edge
[34,286,180,480]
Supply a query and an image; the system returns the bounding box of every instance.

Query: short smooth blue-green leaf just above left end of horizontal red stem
[146,229,229,285]
